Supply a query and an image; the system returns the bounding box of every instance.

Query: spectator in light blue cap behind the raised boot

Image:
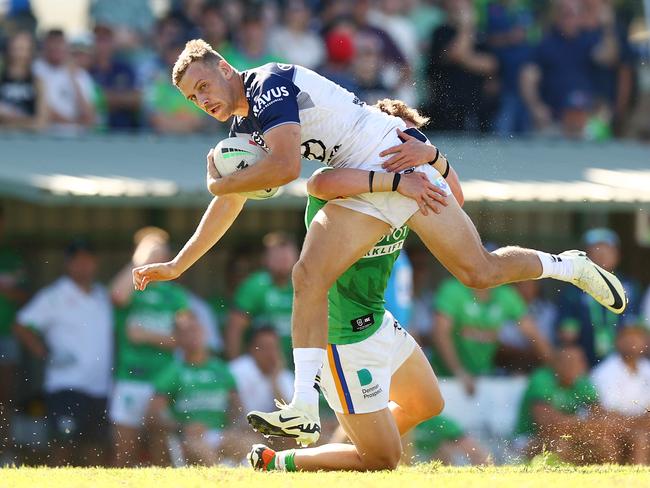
[555,228,639,366]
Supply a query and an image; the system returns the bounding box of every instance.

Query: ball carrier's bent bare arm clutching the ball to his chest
[208,123,300,196]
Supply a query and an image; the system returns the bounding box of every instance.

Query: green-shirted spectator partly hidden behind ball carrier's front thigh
[225,232,298,365]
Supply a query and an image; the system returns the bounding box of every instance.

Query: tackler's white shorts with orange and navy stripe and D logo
[321,311,417,413]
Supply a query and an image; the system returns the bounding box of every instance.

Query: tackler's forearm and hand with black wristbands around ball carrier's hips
[307,168,447,215]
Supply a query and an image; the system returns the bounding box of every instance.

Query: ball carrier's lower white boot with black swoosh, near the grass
[246,400,320,447]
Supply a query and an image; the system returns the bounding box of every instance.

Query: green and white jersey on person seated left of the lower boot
[154,358,237,430]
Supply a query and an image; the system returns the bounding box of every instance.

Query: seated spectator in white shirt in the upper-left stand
[34,30,96,134]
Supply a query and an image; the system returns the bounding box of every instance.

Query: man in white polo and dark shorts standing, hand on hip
[14,240,113,466]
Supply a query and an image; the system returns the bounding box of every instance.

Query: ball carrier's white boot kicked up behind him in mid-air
[558,250,627,314]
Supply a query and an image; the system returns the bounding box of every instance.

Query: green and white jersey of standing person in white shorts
[115,281,188,381]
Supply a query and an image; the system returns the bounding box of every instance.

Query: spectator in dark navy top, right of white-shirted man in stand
[90,24,141,130]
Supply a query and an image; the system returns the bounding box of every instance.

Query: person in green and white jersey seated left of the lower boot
[148,311,256,466]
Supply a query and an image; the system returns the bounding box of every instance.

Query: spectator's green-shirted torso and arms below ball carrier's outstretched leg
[433,278,550,395]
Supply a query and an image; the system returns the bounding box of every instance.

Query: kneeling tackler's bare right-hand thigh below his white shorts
[389,347,445,435]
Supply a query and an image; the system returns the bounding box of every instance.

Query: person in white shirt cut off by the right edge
[591,326,650,464]
